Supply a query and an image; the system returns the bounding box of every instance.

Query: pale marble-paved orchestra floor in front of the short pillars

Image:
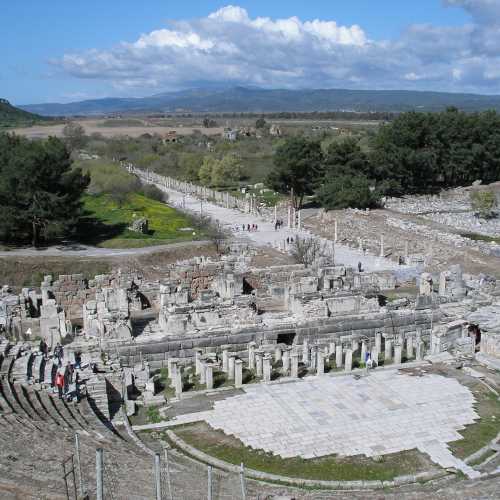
[181,370,479,473]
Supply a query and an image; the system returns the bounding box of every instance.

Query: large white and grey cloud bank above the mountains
[54,4,500,93]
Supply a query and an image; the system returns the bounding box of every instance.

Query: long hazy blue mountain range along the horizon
[19,87,500,116]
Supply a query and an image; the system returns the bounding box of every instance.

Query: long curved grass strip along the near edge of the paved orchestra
[172,422,433,481]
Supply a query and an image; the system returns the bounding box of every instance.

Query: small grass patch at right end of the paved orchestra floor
[450,383,500,458]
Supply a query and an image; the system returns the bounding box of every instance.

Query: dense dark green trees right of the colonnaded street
[268,108,500,209]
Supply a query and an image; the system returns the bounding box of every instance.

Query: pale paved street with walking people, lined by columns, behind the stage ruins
[148,177,415,274]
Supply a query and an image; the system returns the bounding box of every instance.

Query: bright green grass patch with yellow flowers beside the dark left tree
[78,193,205,248]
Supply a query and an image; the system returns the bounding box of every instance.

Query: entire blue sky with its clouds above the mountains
[0,0,500,104]
